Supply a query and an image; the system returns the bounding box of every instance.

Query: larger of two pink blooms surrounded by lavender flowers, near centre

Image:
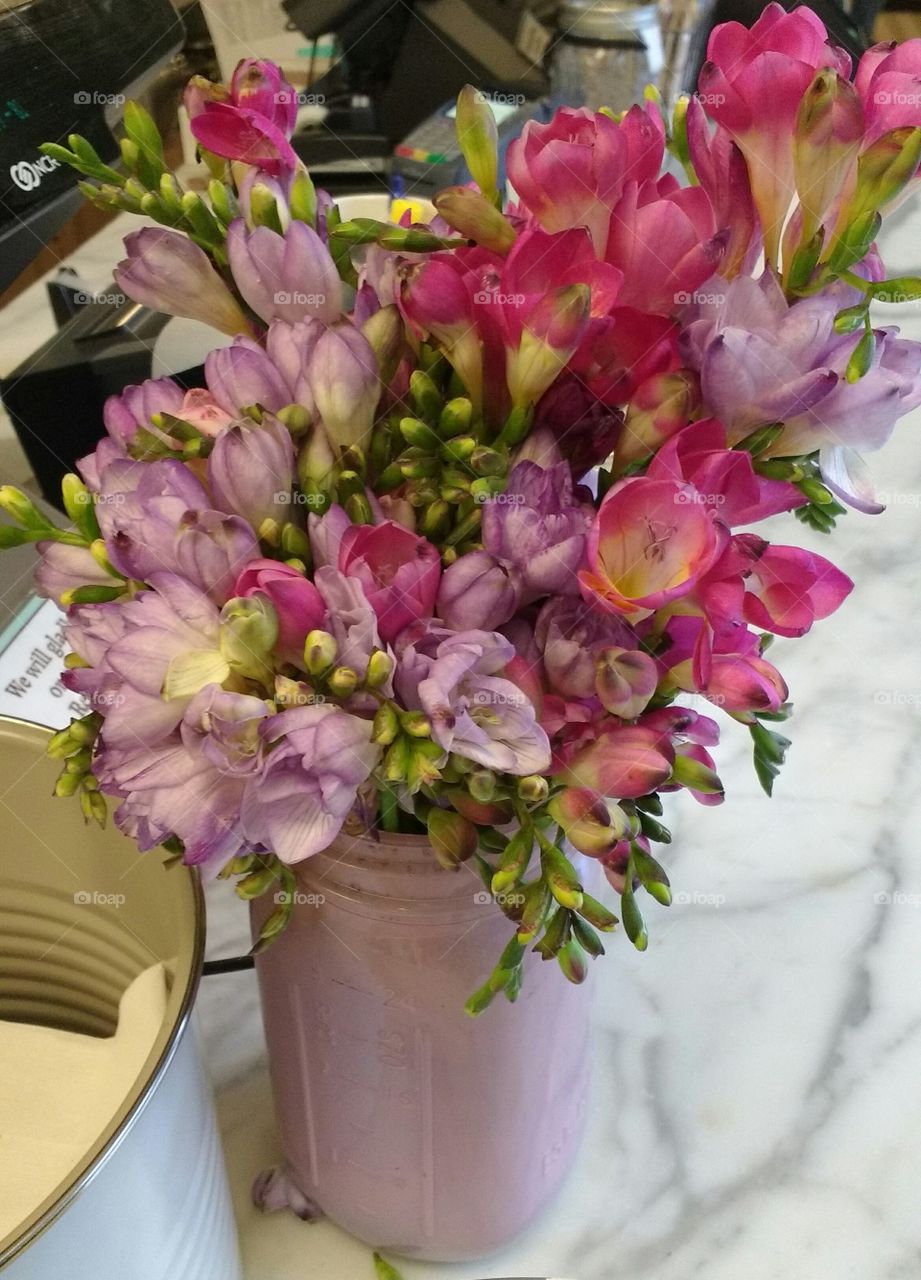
[339,520,441,641]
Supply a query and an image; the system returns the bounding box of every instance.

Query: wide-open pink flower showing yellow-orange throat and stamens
[578,476,728,621]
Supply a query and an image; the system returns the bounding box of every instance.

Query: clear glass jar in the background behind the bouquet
[550,0,664,111]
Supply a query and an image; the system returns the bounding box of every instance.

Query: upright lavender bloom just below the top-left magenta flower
[226,218,342,324]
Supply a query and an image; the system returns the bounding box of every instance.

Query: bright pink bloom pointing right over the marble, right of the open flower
[734,534,853,636]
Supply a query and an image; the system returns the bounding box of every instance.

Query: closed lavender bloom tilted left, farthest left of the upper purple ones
[115,227,249,334]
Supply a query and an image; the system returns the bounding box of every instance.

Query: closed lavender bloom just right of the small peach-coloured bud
[207,415,294,532]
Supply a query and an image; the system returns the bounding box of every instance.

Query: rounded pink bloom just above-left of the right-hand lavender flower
[605,175,728,315]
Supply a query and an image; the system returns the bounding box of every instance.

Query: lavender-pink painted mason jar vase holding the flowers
[253,835,590,1262]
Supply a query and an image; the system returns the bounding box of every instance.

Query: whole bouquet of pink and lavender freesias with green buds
[10,5,921,1011]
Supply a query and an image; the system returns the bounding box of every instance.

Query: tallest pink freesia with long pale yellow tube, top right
[697,4,851,264]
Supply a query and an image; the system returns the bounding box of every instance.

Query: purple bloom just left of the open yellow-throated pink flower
[482,462,591,602]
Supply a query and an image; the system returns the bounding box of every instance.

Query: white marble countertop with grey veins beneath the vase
[0,204,921,1280]
